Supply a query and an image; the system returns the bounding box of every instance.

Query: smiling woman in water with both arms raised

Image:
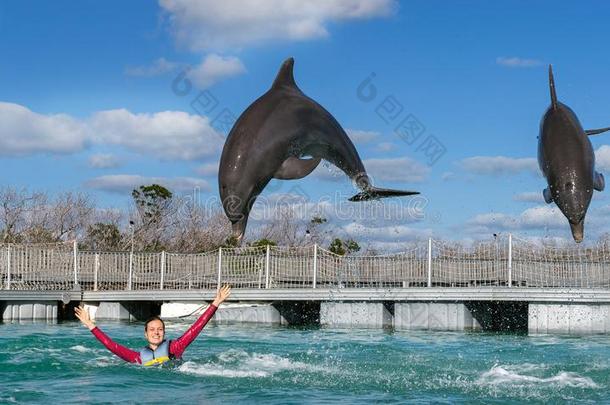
[74,286,231,366]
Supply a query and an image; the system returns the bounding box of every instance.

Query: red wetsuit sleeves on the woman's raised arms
[91,305,218,364]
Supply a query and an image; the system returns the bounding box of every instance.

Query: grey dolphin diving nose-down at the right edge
[538,66,610,243]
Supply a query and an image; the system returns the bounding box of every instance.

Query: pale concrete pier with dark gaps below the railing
[0,287,610,335]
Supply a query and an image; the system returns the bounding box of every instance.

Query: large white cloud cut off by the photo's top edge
[159,0,398,51]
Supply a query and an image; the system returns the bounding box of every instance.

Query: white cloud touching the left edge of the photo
[0,102,87,156]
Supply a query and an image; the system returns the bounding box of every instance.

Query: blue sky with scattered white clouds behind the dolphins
[0,0,610,249]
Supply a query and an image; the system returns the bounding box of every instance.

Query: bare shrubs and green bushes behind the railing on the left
[0,184,360,255]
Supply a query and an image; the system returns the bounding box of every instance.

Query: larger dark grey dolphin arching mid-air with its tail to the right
[218,58,419,243]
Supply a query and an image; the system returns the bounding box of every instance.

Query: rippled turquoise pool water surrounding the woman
[0,322,610,404]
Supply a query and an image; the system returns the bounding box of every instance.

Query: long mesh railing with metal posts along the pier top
[0,235,610,291]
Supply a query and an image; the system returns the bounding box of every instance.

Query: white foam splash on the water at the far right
[478,364,600,388]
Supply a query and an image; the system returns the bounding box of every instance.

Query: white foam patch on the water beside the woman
[178,349,312,378]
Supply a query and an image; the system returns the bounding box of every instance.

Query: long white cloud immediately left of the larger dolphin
[90,109,224,160]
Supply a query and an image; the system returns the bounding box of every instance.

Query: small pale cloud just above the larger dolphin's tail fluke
[363,158,430,182]
